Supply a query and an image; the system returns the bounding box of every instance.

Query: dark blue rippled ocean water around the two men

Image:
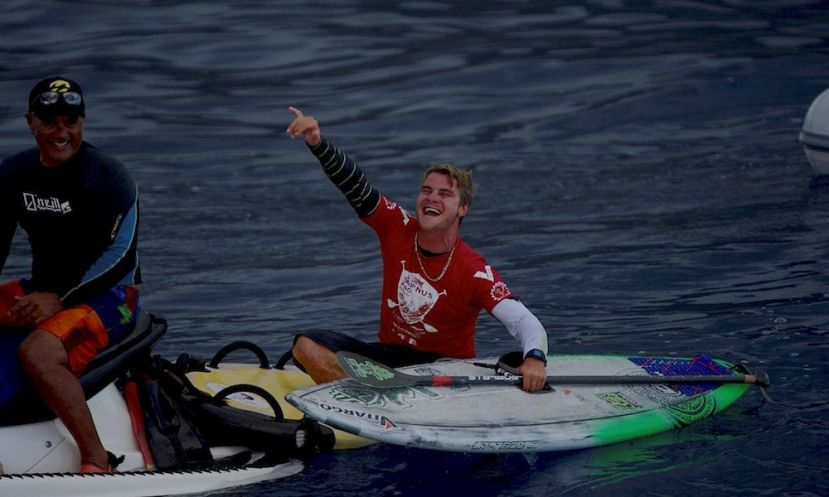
[0,0,829,497]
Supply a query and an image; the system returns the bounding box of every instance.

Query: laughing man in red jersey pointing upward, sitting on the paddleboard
[287,107,547,392]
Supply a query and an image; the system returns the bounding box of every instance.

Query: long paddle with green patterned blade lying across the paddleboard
[337,351,769,388]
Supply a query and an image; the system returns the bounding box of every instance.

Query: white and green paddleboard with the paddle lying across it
[287,353,768,452]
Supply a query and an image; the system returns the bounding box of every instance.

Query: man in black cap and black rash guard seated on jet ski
[0,77,141,472]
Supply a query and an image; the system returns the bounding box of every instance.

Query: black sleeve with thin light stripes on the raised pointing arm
[309,138,380,217]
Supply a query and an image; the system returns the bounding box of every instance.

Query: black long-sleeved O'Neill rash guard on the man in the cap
[0,142,141,307]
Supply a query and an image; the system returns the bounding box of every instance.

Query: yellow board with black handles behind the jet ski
[187,363,376,449]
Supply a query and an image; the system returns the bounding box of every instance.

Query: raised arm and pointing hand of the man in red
[287,107,380,217]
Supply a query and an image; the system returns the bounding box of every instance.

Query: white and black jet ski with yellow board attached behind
[0,313,335,497]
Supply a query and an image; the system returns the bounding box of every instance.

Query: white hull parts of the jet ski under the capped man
[0,384,303,497]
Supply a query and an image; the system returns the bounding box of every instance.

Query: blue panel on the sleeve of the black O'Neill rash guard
[61,194,138,301]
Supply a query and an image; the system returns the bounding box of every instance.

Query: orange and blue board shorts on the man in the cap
[0,279,138,376]
